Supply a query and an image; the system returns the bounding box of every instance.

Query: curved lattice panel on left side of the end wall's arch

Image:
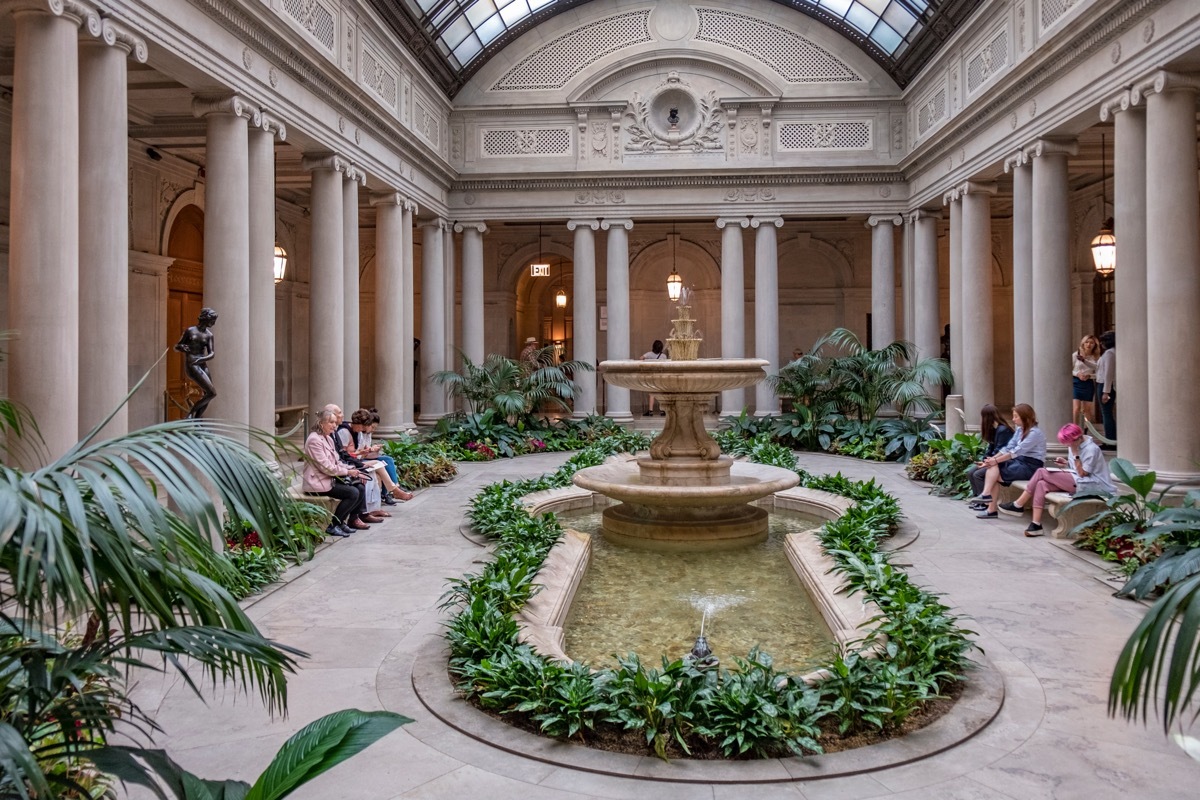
[492,10,654,91]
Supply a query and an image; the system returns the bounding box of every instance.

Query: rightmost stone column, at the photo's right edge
[1132,72,1200,485]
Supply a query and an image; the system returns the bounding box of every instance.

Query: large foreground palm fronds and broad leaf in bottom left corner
[0,390,408,800]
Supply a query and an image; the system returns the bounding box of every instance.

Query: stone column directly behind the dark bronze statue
[191,95,255,438]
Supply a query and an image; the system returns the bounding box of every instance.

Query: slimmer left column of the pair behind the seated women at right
[1004,150,1037,409]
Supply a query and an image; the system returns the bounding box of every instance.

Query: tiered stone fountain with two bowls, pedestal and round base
[574,359,799,549]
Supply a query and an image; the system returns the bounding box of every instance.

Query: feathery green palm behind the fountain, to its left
[433,345,595,425]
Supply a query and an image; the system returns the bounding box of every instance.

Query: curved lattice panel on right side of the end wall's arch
[696,8,863,83]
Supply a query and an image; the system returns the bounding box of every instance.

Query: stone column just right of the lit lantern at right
[1100,91,1150,469]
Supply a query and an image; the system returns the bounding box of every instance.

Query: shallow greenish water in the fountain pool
[558,511,836,673]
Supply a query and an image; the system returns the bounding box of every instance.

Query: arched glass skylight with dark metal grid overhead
[371,0,983,97]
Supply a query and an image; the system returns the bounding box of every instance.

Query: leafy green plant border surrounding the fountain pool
[443,432,974,758]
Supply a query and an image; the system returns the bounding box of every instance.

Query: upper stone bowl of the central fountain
[600,359,770,393]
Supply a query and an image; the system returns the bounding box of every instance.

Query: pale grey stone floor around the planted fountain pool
[127,455,1200,800]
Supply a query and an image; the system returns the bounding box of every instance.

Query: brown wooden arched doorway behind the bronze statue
[163,205,204,420]
